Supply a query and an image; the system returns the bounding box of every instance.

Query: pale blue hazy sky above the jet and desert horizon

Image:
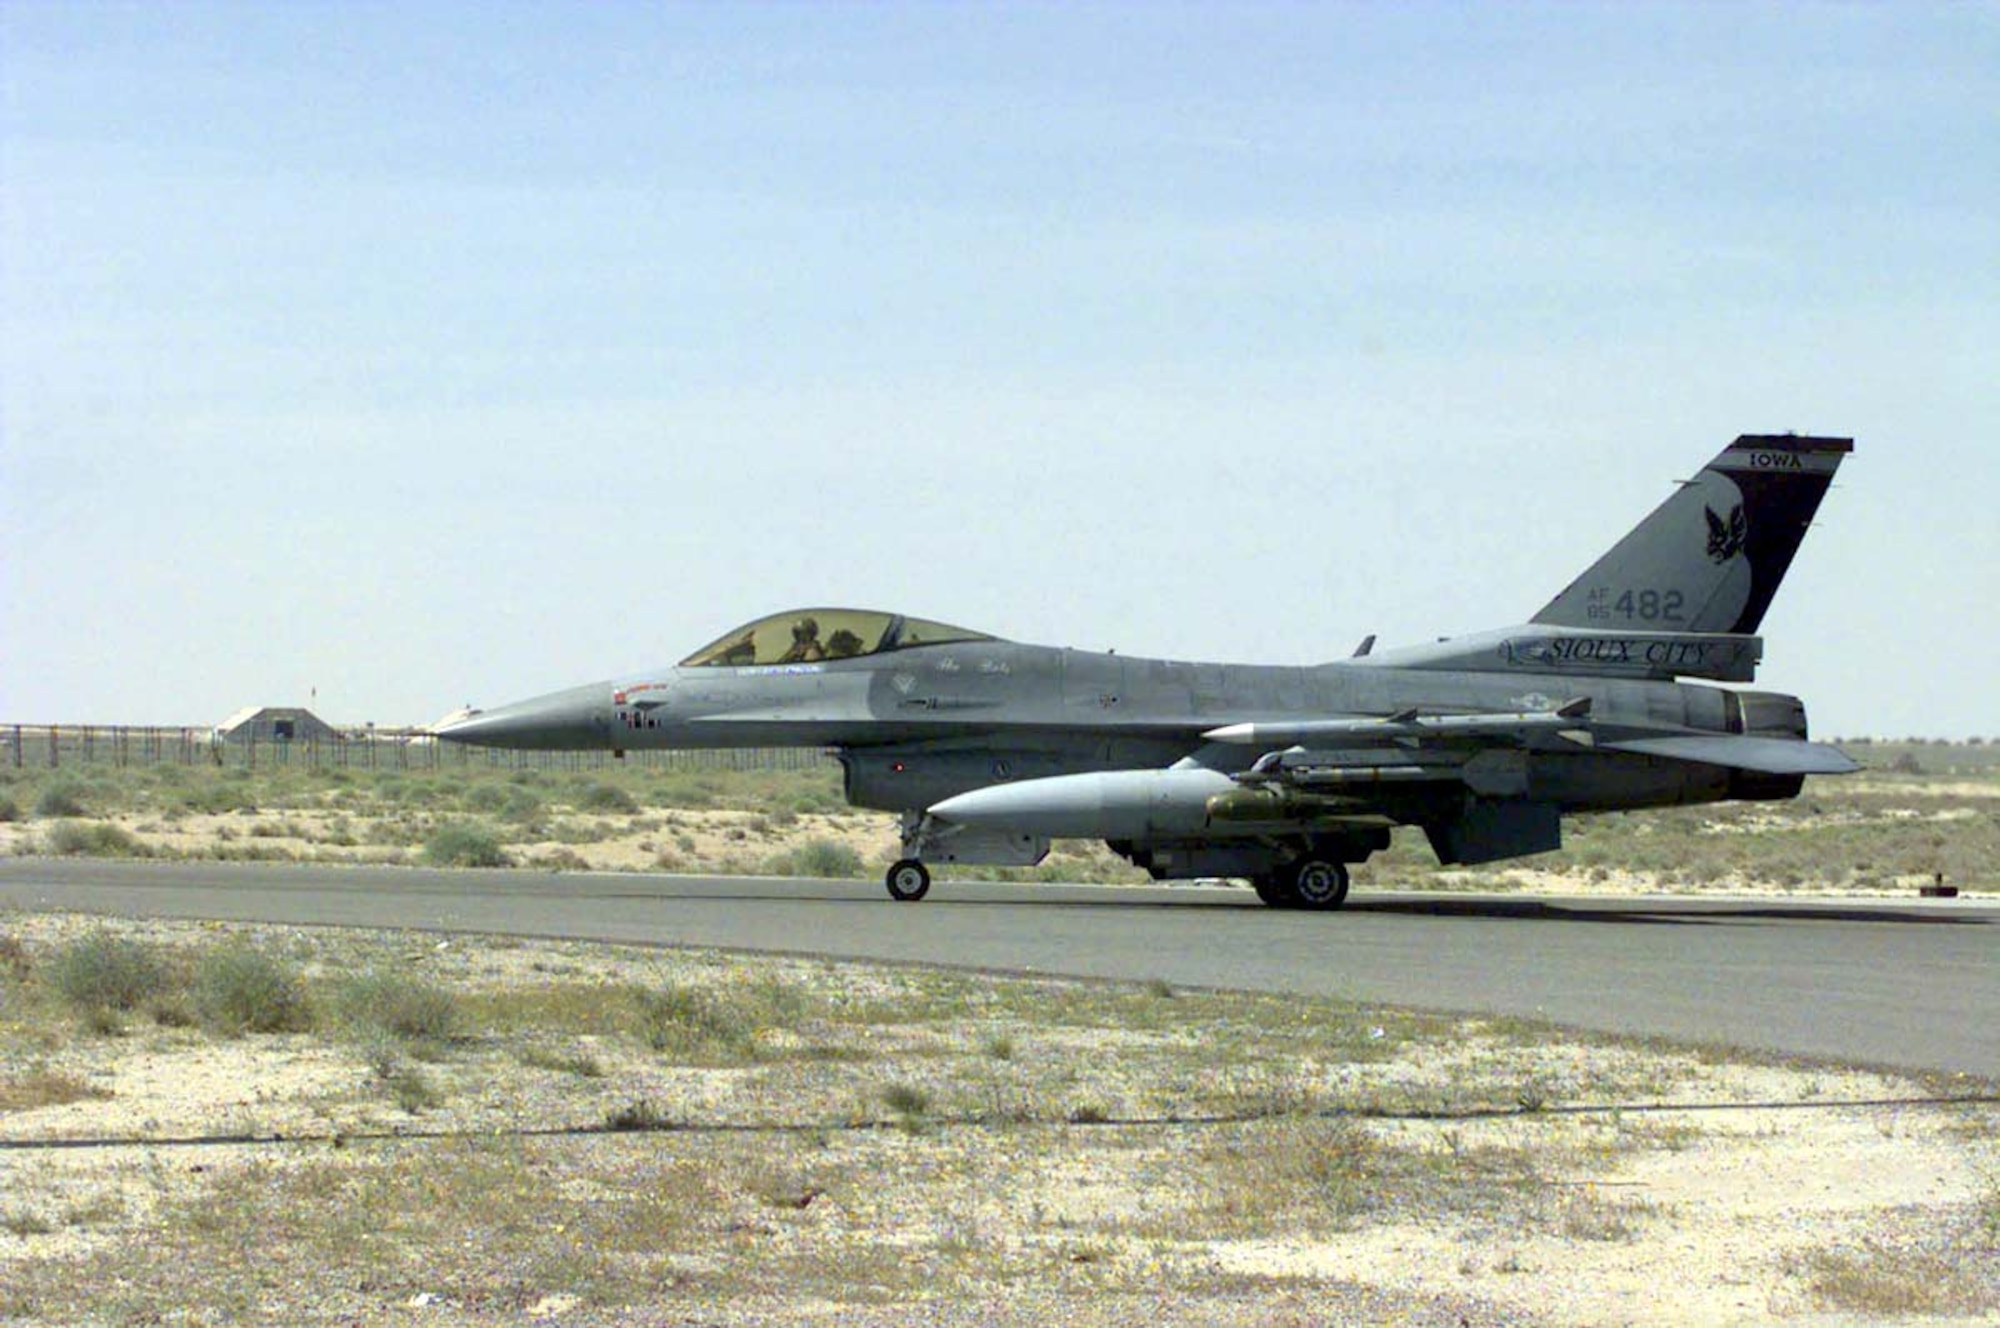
[0,0,2000,736]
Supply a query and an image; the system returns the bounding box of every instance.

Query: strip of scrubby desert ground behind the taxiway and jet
[0,742,2000,896]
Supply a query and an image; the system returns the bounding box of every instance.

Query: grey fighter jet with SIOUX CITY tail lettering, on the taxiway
[436,434,1856,910]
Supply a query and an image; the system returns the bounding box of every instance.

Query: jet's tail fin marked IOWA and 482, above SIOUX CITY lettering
[1532,434,1854,636]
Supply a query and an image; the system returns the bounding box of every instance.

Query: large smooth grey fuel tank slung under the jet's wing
[930,766,1238,840]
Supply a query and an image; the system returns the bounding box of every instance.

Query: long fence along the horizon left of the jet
[0,724,832,770]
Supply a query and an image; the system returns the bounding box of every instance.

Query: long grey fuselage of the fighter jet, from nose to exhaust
[452,642,1804,812]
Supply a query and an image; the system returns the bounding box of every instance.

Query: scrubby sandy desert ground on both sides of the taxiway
[0,744,2000,1324]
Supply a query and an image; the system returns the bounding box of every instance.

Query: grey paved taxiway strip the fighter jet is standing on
[0,858,2000,1078]
